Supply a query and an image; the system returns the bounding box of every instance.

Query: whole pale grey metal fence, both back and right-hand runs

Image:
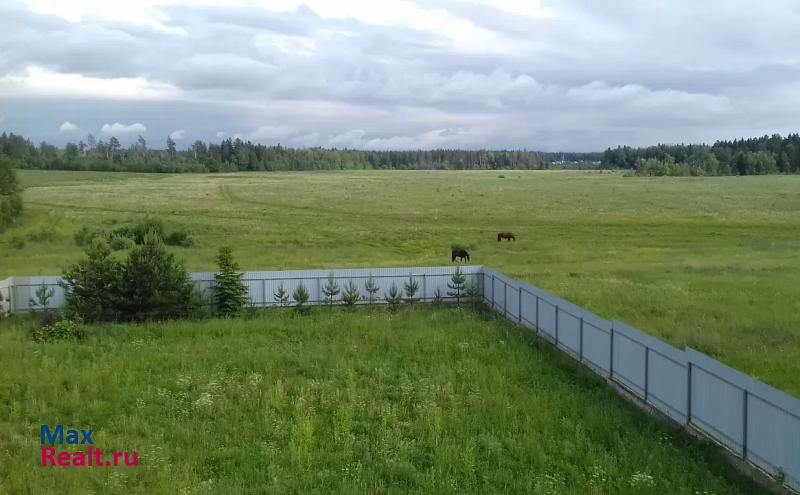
[0,266,800,491]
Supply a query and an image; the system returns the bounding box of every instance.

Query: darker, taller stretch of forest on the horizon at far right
[601,134,800,175]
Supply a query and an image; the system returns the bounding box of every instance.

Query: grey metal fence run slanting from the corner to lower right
[483,268,800,491]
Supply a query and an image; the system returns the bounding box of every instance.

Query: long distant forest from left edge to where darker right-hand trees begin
[0,133,555,172]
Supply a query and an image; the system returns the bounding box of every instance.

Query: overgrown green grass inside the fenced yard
[0,305,761,495]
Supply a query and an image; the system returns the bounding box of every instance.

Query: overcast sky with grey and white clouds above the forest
[0,0,800,151]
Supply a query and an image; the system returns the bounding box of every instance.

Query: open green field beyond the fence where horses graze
[0,171,800,395]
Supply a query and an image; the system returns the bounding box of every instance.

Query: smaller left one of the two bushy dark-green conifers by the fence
[60,239,123,322]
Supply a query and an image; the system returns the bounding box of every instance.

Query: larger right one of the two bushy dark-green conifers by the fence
[118,231,194,321]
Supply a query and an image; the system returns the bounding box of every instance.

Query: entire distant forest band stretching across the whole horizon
[0,132,800,176]
